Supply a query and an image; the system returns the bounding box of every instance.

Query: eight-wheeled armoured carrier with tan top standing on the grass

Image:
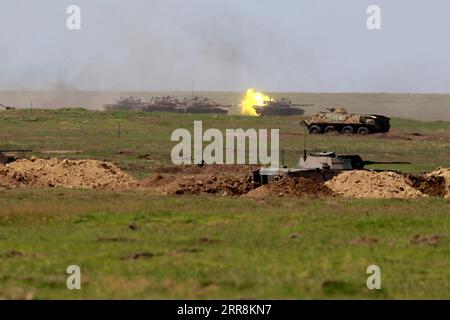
[302,108,390,135]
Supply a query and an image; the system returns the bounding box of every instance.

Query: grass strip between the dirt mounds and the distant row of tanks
[0,109,450,178]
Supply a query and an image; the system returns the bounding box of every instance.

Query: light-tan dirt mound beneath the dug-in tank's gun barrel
[325,170,425,199]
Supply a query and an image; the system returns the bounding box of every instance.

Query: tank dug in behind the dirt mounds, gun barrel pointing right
[252,151,410,187]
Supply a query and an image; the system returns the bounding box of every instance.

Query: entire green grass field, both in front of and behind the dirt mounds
[0,109,450,299]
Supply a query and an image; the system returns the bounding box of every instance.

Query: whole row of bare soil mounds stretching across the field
[0,158,450,200]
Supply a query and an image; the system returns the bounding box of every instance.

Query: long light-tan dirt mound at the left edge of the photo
[0,158,137,189]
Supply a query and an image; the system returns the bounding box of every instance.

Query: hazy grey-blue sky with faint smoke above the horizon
[0,0,450,93]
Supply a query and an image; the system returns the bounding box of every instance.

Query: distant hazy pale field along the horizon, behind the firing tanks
[0,88,450,121]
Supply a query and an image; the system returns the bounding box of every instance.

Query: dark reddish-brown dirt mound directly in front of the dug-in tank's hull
[245,177,332,198]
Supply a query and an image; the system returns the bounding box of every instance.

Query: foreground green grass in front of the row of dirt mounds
[0,190,450,299]
